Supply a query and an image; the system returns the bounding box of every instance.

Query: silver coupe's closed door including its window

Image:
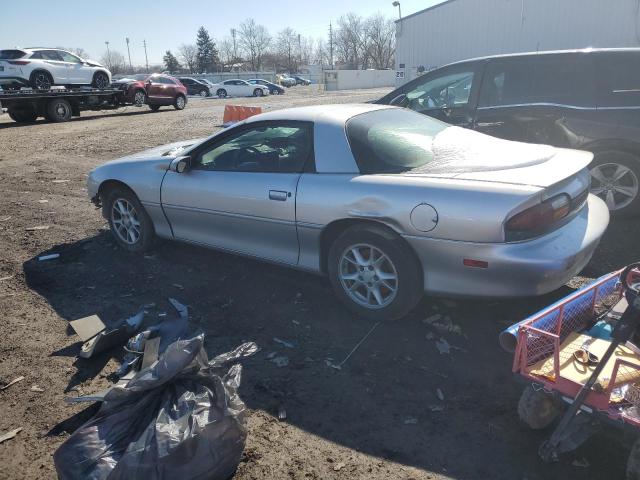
[161,121,313,265]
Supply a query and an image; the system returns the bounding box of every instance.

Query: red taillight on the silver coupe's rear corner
[505,193,571,242]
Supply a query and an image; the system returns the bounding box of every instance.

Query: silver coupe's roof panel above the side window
[246,103,398,124]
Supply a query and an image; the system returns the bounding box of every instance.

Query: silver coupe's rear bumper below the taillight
[404,195,609,297]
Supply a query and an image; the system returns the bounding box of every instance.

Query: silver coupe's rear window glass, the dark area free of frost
[346,108,450,174]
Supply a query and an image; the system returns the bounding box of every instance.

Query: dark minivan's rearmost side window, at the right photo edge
[596,52,640,107]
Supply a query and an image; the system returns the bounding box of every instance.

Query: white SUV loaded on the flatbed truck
[0,48,111,90]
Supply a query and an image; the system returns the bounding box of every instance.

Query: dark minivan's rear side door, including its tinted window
[474,53,595,148]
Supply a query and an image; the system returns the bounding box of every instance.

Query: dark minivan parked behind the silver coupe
[376,49,640,216]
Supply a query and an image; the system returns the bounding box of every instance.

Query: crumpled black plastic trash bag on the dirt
[53,335,258,480]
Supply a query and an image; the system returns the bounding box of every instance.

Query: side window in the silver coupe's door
[193,122,313,173]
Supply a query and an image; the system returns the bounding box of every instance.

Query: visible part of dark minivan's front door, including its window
[401,62,484,127]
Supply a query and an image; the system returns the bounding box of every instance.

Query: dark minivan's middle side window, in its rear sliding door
[479,56,593,107]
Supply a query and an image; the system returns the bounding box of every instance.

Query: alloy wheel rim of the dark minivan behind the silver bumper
[591,163,639,211]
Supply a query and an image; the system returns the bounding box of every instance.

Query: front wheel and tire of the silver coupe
[102,187,156,253]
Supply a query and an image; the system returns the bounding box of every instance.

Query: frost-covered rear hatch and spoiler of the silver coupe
[407,127,593,188]
